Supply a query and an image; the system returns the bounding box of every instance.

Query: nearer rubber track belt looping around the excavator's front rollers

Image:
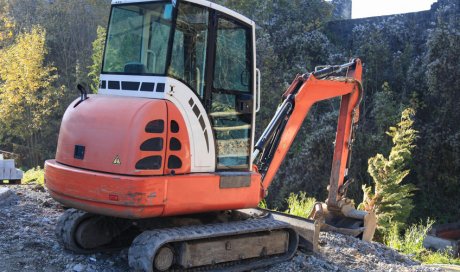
[129,218,299,272]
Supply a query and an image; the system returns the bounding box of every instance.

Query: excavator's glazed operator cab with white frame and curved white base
[99,1,256,172]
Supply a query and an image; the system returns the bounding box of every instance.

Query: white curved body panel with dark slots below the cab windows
[99,74,216,173]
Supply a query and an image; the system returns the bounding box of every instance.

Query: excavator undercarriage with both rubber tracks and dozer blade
[56,209,320,272]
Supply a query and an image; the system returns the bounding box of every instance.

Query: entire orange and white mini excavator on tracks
[45,0,375,271]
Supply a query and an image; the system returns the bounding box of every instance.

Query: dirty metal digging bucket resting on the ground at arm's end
[309,198,377,242]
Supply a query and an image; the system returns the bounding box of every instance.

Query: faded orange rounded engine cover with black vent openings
[56,95,190,175]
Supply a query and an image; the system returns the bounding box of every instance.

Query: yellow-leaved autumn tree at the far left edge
[0,27,61,166]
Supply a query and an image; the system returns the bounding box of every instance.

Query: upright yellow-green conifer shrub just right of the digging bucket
[360,108,417,238]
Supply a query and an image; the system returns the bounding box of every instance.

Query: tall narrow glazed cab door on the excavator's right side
[207,14,255,171]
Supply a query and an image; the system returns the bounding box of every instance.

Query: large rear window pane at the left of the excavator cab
[102,2,173,75]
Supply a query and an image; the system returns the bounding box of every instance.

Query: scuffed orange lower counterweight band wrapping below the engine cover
[45,160,261,219]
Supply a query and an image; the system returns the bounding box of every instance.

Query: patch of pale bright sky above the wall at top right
[352,0,436,18]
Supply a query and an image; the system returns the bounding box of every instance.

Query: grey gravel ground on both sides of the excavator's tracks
[0,186,442,272]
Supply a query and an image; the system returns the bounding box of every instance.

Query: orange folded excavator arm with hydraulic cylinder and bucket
[252,59,375,240]
